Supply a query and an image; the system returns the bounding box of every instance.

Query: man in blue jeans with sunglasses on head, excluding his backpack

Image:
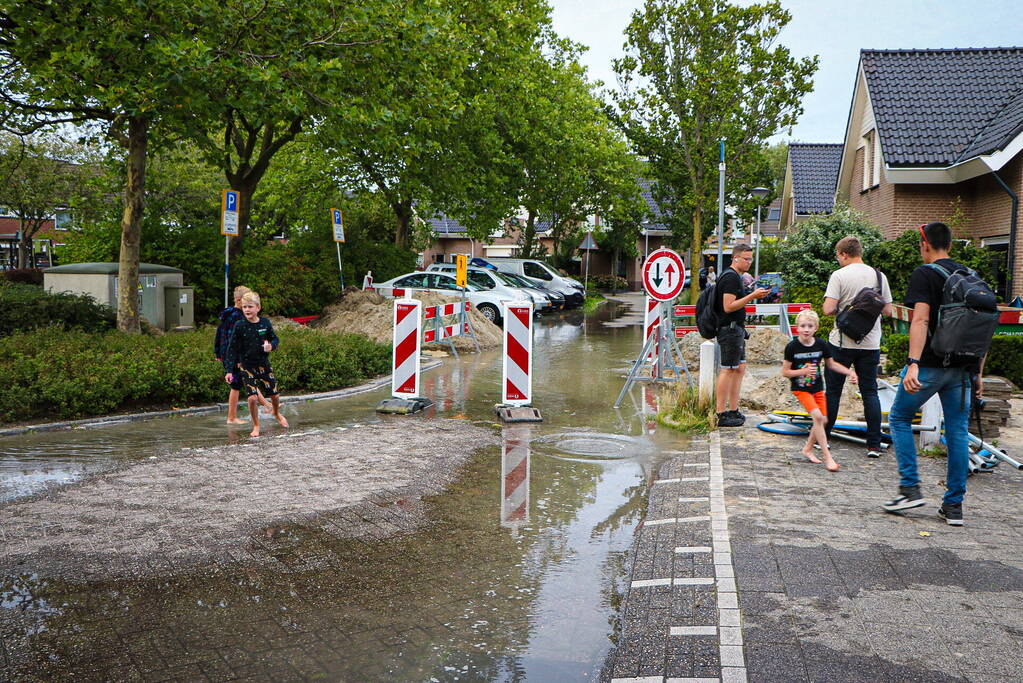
[884,223,983,527]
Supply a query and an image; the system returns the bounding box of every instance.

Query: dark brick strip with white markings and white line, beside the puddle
[602,434,746,683]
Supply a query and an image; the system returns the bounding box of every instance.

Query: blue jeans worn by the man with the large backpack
[888,368,972,504]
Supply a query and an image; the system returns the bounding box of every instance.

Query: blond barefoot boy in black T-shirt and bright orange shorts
[782,311,856,472]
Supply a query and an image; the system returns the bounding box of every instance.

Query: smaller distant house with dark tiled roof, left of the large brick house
[779,142,843,228]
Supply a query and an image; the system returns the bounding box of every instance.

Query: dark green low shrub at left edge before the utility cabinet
[0,282,117,336]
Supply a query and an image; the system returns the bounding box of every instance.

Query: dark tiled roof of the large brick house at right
[860,47,1023,167]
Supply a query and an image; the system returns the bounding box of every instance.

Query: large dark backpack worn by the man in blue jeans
[928,263,998,365]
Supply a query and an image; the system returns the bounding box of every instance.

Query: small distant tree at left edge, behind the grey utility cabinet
[0,135,82,268]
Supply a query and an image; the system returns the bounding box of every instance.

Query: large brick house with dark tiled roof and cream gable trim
[838,47,1023,299]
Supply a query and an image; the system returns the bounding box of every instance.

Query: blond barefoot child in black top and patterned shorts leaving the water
[224,291,287,437]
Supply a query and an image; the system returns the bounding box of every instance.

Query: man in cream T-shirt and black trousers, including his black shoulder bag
[822,235,892,458]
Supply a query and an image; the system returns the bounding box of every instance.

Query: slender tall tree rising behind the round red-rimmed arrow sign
[612,0,817,302]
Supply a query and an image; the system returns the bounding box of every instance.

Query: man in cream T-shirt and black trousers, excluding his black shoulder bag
[824,235,892,458]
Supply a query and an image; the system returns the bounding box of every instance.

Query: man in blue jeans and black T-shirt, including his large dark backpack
[884,223,998,527]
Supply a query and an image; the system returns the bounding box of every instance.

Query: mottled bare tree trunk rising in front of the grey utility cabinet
[118,117,149,334]
